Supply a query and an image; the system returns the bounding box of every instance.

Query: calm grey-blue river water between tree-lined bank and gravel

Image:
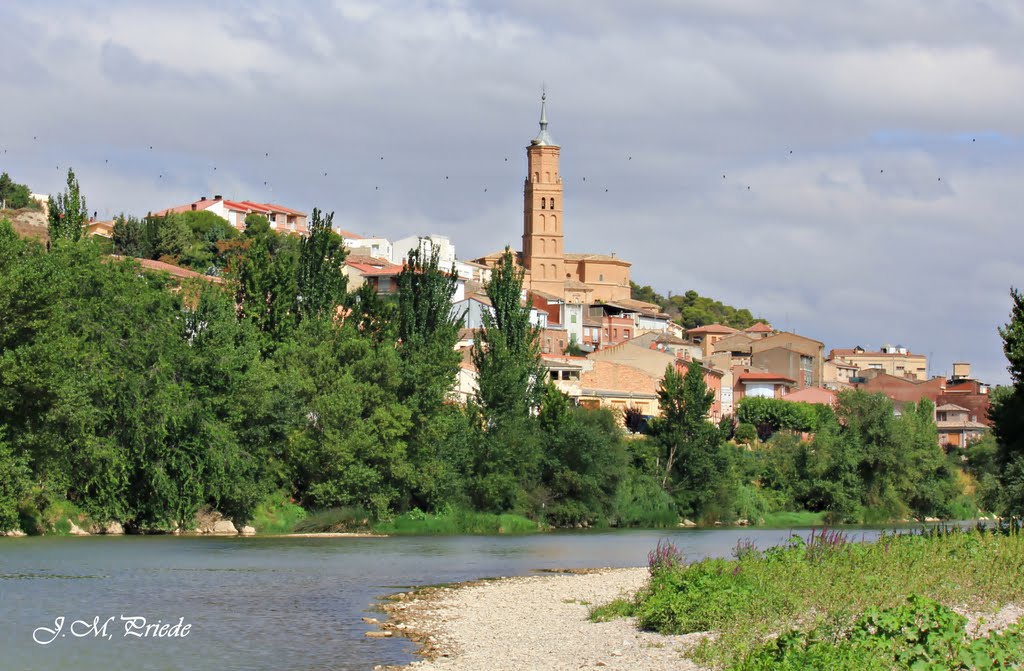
[0,529,913,671]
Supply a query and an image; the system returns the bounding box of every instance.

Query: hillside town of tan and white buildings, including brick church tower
[64,96,990,448]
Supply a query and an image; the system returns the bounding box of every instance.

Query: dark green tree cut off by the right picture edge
[989,289,1024,516]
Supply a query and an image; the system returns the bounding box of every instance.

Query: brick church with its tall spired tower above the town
[476,95,631,304]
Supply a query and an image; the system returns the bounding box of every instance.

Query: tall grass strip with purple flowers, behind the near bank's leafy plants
[592,529,1024,665]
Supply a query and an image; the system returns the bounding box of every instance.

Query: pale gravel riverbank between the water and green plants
[376,569,701,671]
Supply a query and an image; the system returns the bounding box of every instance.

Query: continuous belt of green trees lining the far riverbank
[0,172,1024,533]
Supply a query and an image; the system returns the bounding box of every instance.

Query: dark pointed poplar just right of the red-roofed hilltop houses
[295,208,348,319]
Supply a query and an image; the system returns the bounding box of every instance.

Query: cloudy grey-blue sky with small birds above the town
[0,0,1024,383]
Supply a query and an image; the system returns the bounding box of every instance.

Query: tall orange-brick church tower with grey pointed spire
[522,93,565,297]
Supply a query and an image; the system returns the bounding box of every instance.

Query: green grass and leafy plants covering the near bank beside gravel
[591,523,1024,671]
